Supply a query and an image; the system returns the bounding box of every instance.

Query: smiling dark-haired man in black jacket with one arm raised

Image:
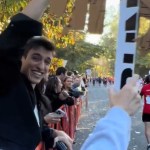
[0,0,71,150]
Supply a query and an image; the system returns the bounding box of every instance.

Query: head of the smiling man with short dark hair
[21,37,55,88]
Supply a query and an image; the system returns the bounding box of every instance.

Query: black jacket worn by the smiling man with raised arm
[0,14,52,150]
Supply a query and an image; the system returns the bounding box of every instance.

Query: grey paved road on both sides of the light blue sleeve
[74,85,146,150]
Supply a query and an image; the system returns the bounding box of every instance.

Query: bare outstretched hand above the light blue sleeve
[109,75,141,115]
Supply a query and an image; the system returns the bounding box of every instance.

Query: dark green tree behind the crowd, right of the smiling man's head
[57,40,104,71]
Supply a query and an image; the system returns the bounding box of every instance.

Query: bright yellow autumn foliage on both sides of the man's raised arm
[0,0,84,48]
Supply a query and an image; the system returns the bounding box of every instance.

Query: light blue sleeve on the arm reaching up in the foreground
[81,107,131,150]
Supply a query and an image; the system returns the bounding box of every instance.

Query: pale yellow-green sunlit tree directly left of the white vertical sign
[94,14,119,75]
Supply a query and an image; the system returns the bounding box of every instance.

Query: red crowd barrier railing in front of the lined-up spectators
[36,92,88,150]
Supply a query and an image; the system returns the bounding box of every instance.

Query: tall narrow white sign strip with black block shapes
[115,0,139,90]
